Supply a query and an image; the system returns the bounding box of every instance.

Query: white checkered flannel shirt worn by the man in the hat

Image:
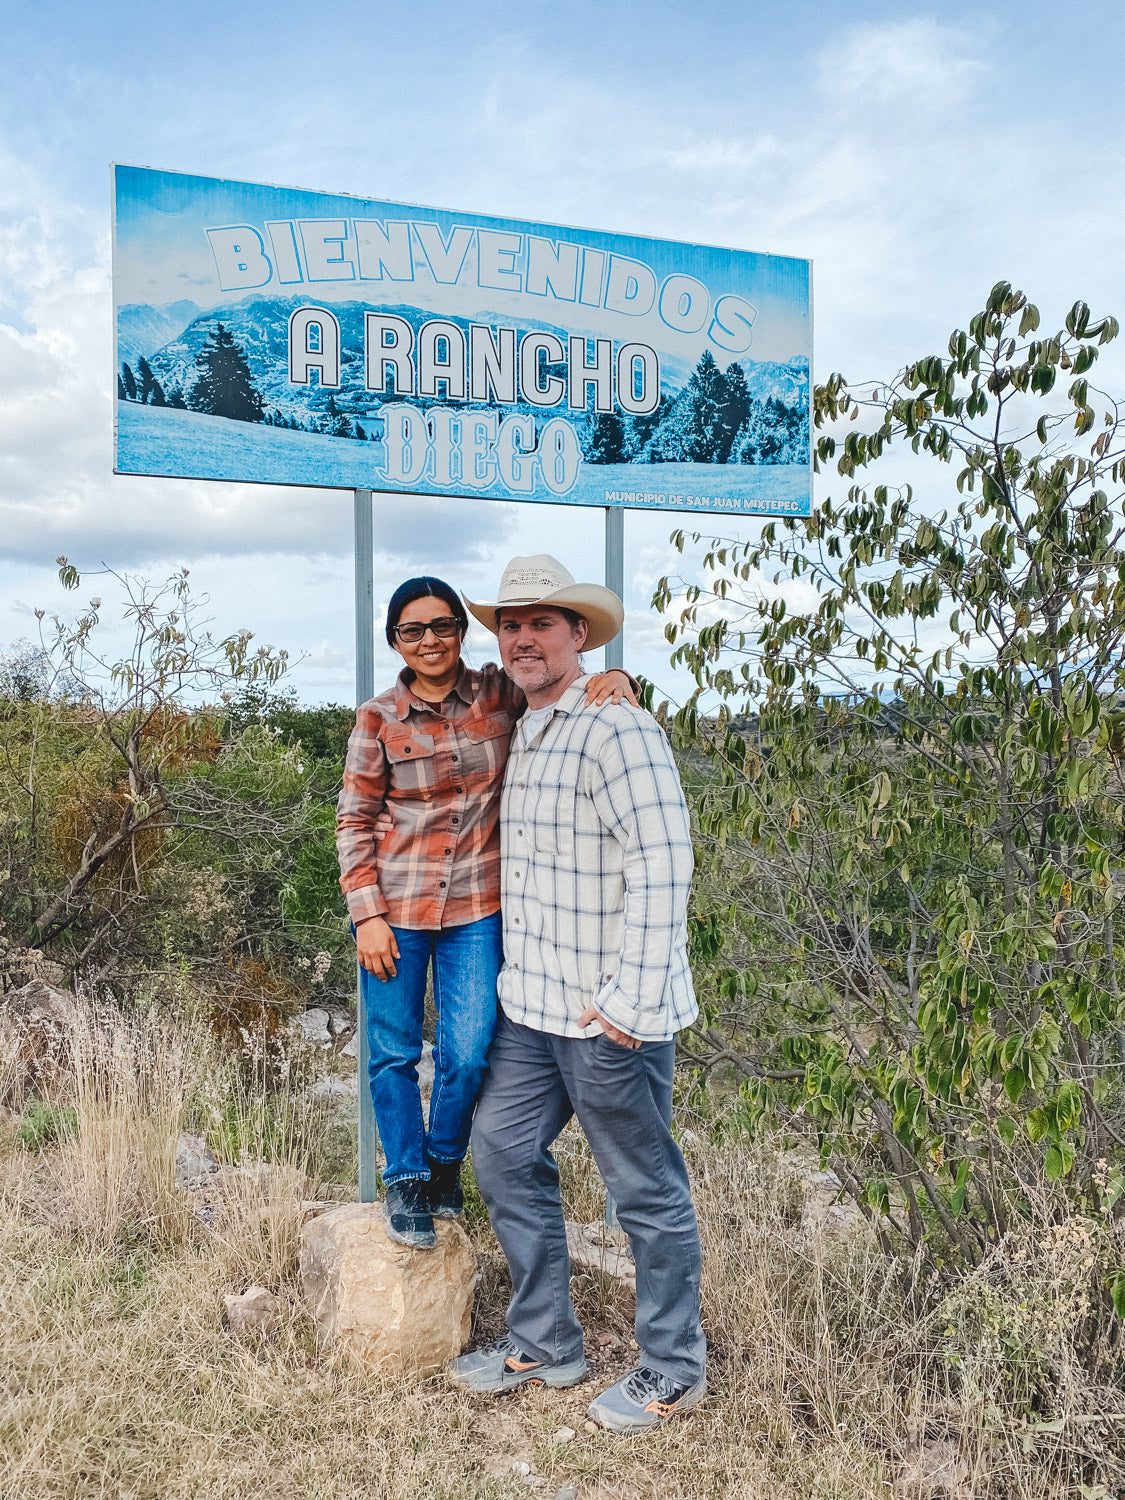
[500,678,699,1041]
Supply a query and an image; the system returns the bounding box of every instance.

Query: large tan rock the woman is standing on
[300,1203,476,1374]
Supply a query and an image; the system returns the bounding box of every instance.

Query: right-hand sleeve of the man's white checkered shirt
[588,711,695,1035]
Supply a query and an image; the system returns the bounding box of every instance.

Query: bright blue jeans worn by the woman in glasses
[360,912,504,1187]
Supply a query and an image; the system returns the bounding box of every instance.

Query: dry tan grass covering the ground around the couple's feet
[0,1017,1125,1500]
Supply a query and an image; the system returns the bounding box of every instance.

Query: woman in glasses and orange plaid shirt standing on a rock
[336,578,632,1250]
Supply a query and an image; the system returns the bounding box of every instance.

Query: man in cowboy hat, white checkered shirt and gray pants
[452,557,705,1433]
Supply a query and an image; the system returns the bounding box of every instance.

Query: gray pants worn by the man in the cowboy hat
[473,1016,707,1385]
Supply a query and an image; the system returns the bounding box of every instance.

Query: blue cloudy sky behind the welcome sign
[0,0,1125,702]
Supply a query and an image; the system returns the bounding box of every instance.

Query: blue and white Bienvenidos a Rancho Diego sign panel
[114,167,812,516]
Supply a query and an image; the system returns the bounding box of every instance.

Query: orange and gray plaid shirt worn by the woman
[336,663,525,930]
